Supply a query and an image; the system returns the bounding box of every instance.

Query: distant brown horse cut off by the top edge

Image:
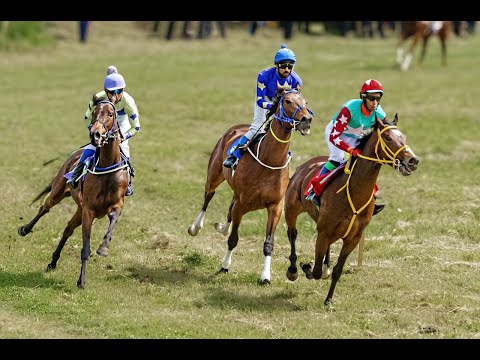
[397,21,452,71]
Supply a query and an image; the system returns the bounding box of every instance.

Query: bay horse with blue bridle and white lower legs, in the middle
[188,90,314,285]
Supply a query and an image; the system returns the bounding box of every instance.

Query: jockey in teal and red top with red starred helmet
[305,79,387,215]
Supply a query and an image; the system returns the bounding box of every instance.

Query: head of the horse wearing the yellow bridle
[375,114,419,176]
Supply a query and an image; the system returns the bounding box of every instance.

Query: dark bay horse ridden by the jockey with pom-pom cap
[18,96,128,289]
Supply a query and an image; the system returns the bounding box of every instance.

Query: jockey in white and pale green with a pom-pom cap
[67,65,140,196]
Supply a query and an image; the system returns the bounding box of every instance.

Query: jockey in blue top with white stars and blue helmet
[223,44,302,169]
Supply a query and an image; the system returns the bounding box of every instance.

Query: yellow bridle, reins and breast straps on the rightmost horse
[337,125,409,239]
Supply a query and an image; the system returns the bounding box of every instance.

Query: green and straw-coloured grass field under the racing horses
[0,22,480,339]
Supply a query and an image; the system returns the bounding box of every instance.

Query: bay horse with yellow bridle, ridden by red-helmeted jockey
[284,115,419,305]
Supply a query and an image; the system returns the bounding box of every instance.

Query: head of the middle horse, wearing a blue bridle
[274,90,315,135]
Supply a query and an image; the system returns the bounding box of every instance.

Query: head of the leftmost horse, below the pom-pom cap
[89,96,118,147]
